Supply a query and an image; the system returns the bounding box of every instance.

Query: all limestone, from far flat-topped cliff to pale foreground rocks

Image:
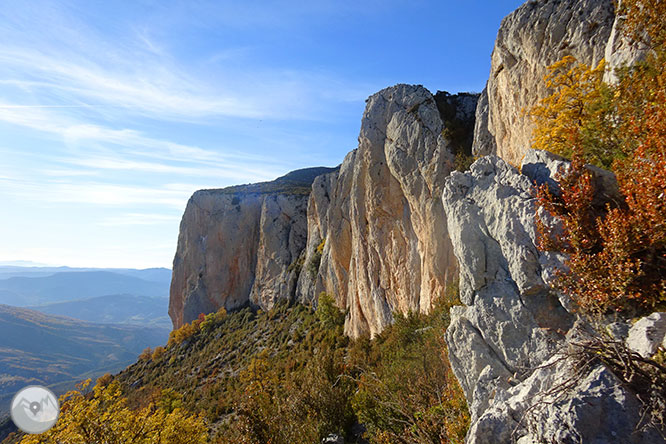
[163,0,666,444]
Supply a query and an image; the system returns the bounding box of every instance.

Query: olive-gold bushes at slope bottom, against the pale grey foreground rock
[350,287,469,444]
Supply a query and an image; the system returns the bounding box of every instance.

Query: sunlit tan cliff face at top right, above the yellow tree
[475,0,615,165]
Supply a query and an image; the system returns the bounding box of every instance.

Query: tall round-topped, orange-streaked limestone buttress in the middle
[298,85,477,336]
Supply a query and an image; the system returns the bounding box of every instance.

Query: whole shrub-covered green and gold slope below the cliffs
[6,291,469,444]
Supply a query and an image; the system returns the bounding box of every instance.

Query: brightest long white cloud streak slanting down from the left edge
[0,46,265,120]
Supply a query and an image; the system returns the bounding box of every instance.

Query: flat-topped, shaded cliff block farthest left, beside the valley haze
[169,168,332,328]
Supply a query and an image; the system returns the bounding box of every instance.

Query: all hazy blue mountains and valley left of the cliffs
[0,266,171,417]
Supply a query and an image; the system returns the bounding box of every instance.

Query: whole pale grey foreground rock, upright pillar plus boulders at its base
[442,151,664,444]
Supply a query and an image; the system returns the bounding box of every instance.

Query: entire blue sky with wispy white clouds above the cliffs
[0,0,522,268]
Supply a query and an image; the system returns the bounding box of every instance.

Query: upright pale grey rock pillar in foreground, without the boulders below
[443,152,573,406]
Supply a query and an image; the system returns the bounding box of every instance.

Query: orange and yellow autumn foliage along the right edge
[534,0,666,312]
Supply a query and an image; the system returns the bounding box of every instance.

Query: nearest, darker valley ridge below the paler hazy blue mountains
[0,305,169,412]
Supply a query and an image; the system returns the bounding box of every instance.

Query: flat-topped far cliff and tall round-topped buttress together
[169,85,477,336]
